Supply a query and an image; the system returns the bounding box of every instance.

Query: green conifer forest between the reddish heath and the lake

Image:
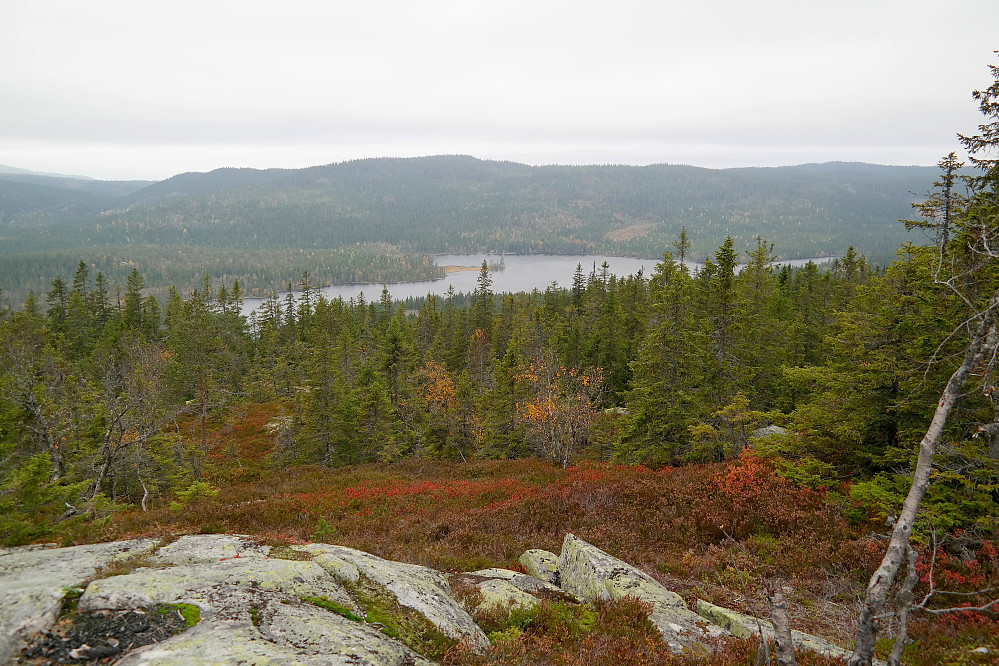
[0,231,996,541]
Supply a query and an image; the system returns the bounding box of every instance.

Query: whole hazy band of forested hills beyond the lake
[0,156,936,302]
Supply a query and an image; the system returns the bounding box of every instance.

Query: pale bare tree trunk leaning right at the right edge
[847,294,999,666]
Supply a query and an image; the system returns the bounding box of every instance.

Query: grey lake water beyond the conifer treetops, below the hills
[243,254,832,314]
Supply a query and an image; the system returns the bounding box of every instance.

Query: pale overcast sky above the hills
[0,0,999,179]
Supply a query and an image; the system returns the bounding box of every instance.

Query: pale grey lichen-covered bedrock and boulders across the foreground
[0,534,864,665]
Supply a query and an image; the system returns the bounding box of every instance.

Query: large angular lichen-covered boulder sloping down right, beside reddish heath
[558,534,729,653]
